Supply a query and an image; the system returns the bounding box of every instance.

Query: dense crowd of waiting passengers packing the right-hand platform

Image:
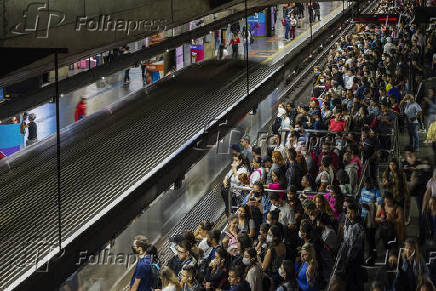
[127,1,436,291]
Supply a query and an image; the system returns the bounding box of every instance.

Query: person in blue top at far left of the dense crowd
[130,240,153,291]
